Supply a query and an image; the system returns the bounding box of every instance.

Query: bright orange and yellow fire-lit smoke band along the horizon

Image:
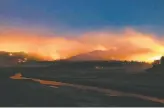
[0,29,164,62]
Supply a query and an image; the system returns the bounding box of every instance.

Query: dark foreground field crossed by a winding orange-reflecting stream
[0,61,164,107]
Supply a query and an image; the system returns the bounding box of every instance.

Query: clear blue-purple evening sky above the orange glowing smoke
[0,0,164,33]
